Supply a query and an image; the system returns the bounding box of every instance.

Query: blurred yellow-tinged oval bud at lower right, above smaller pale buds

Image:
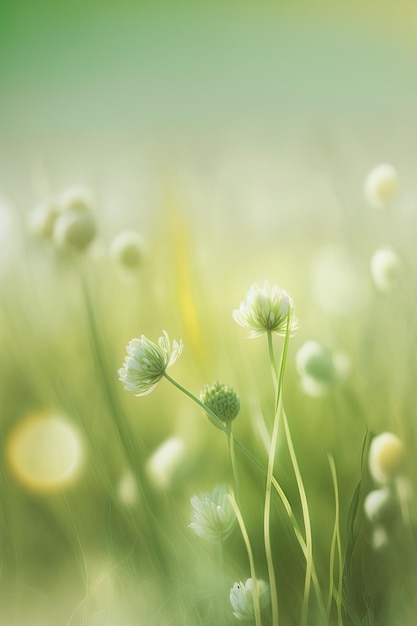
[368,433,405,485]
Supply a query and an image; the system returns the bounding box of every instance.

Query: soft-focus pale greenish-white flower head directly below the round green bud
[189,485,236,543]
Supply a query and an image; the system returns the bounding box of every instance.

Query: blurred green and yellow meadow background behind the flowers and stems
[0,0,417,626]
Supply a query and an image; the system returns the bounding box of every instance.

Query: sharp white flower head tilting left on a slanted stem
[118,330,183,396]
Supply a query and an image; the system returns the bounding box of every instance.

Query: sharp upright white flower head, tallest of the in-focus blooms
[233,280,297,337]
